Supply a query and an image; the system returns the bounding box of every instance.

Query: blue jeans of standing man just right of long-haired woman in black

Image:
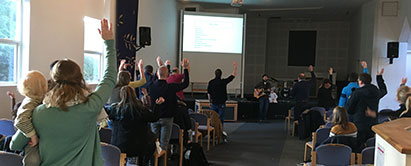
[151,118,174,150]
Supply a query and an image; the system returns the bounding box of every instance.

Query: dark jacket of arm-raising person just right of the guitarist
[291,72,317,102]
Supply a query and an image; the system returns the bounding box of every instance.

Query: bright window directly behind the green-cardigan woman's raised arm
[84,17,104,83]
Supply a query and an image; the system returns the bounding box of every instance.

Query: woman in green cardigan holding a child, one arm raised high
[10,19,117,166]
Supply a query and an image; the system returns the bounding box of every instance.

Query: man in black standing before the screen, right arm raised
[207,62,237,125]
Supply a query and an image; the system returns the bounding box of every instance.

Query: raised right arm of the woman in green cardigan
[86,19,117,111]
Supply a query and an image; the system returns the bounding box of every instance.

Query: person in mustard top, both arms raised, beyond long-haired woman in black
[108,59,146,104]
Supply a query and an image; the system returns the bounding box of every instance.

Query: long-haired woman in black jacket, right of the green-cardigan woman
[107,85,164,165]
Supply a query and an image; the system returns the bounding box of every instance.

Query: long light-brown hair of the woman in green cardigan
[44,59,89,111]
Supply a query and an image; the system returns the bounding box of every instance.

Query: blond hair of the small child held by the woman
[17,70,47,100]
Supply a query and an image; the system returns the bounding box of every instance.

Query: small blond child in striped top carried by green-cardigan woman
[14,71,47,166]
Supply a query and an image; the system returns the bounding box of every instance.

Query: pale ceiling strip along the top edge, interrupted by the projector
[180,0,370,19]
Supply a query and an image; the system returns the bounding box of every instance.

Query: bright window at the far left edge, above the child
[0,0,22,84]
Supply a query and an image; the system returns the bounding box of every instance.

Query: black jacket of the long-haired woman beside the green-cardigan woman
[107,103,162,157]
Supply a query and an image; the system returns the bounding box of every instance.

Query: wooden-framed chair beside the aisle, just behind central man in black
[190,113,215,151]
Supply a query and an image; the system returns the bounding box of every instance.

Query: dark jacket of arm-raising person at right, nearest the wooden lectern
[345,76,387,131]
